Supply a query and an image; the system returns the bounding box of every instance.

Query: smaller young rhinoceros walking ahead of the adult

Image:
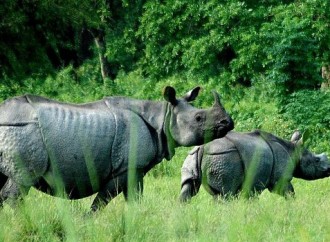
[180,130,330,201]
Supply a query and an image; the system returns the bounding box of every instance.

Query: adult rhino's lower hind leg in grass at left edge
[0,178,30,205]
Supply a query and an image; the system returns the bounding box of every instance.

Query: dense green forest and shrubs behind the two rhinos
[0,0,330,151]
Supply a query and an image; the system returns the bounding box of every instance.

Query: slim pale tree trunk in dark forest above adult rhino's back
[91,30,115,84]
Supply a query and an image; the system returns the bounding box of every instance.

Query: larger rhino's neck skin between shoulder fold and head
[104,97,174,163]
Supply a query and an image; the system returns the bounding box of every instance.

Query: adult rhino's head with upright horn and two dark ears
[164,86,234,157]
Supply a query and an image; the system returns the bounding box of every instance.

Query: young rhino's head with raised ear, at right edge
[291,131,330,180]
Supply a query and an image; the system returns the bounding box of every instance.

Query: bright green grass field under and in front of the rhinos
[0,147,330,242]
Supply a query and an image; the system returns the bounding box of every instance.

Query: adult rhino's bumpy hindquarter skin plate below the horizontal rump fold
[0,122,47,186]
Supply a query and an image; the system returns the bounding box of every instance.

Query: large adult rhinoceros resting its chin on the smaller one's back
[0,87,233,210]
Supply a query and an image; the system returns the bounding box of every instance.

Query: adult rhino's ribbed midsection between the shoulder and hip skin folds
[38,106,116,198]
